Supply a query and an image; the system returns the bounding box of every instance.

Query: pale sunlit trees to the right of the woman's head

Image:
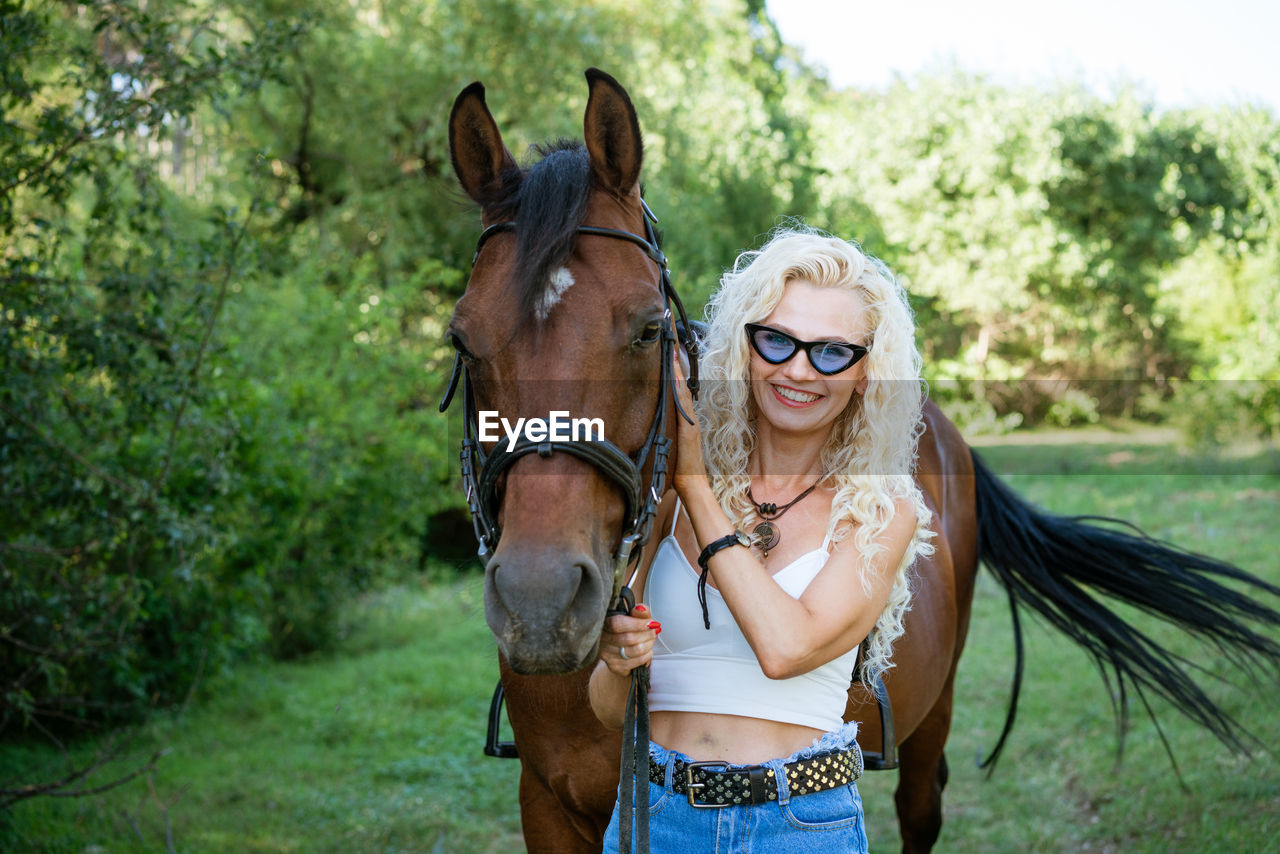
[815,73,1280,429]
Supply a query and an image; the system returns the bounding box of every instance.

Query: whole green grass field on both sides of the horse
[0,431,1280,854]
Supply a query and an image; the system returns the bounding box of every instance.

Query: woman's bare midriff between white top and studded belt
[649,712,823,766]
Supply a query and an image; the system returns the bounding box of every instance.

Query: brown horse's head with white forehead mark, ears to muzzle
[449,69,678,673]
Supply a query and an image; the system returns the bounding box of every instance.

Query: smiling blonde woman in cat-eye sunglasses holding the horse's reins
[590,229,931,854]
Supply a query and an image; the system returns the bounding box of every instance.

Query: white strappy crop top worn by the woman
[644,504,858,732]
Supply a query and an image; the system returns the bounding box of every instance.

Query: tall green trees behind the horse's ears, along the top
[220,0,818,302]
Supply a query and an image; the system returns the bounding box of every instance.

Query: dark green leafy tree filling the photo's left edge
[0,4,286,731]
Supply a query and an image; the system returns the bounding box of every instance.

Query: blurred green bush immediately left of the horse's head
[219,243,461,656]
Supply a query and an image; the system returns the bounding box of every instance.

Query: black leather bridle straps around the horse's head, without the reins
[440,200,699,602]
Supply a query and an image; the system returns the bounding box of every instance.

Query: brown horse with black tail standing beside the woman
[445,69,1280,853]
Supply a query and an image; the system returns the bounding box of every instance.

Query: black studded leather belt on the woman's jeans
[649,746,863,808]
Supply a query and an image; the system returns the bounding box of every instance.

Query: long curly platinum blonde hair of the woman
[698,225,933,685]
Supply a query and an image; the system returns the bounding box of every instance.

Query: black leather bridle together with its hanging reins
[440,200,699,853]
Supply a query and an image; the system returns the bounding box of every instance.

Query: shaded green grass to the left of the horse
[0,577,521,853]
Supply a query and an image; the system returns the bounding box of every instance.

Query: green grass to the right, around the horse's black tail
[861,430,1280,854]
